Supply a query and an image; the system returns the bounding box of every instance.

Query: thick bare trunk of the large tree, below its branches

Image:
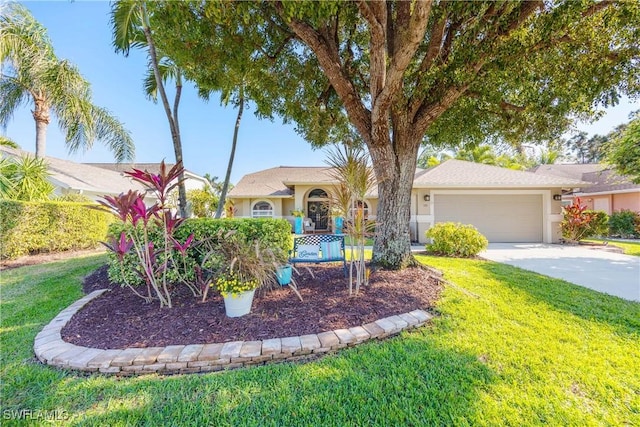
[369,129,420,269]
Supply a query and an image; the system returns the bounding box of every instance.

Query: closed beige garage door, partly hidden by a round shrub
[434,194,542,242]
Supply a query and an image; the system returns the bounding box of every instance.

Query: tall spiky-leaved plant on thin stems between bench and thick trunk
[326,145,375,295]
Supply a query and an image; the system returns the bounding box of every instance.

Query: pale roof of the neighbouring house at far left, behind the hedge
[0,147,144,194]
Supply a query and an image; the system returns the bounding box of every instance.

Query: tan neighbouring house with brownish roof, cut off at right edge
[533,164,640,215]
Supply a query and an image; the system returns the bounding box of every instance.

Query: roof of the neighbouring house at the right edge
[534,163,640,194]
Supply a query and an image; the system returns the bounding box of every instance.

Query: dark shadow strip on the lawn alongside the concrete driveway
[479,261,640,335]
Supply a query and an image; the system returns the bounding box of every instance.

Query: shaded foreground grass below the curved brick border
[26,331,493,426]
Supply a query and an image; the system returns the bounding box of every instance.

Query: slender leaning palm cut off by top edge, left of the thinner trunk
[111,0,187,218]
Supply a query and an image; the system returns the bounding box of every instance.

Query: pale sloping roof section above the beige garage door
[413,159,585,188]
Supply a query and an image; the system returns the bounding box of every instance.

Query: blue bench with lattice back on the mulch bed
[289,234,347,277]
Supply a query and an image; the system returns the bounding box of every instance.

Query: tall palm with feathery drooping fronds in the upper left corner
[0,3,134,161]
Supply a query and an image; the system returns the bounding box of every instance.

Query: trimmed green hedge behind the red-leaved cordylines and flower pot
[109,218,291,284]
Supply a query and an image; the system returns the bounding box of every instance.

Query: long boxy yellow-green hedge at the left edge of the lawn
[0,200,112,259]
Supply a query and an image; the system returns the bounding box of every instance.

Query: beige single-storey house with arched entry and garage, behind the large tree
[229,159,585,243]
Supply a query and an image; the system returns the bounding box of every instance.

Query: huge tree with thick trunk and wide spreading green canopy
[154,1,640,268]
